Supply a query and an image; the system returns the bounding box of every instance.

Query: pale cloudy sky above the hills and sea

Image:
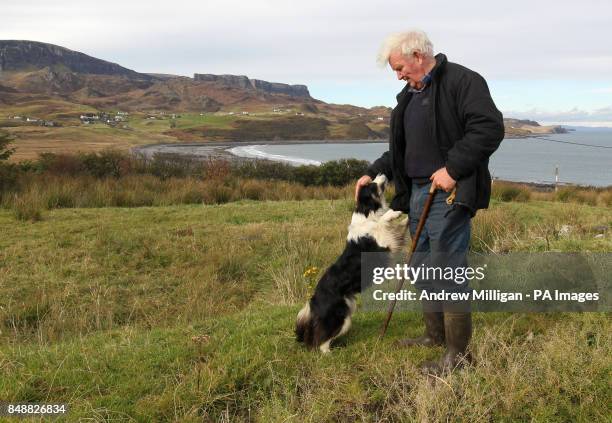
[0,0,612,127]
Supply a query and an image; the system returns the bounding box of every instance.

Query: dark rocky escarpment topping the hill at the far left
[0,40,152,80]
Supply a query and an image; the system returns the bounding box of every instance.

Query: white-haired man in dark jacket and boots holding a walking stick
[355,30,504,374]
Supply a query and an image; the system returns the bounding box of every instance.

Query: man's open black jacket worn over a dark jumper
[366,54,504,215]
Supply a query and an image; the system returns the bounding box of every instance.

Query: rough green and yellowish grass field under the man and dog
[0,199,612,422]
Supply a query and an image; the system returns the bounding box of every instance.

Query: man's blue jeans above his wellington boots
[409,183,471,302]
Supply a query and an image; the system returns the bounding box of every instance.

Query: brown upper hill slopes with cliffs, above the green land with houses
[0,40,314,111]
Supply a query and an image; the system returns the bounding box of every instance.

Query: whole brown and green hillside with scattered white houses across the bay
[0,40,559,160]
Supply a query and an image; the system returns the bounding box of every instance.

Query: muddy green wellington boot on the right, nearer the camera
[421,313,472,375]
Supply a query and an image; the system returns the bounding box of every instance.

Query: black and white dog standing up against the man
[295,175,406,353]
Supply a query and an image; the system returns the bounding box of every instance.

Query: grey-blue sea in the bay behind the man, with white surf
[228,126,612,187]
